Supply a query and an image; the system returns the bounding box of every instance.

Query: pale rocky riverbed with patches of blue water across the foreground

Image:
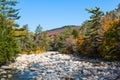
[0,52,120,80]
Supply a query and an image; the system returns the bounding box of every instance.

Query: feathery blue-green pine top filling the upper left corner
[0,0,20,20]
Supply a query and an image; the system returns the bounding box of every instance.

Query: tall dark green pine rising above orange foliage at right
[86,7,103,56]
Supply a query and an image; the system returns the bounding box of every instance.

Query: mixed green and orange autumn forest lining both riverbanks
[0,0,120,65]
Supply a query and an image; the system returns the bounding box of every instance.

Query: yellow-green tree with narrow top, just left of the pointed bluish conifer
[20,24,36,52]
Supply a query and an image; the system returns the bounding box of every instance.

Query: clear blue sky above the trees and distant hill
[17,0,120,31]
